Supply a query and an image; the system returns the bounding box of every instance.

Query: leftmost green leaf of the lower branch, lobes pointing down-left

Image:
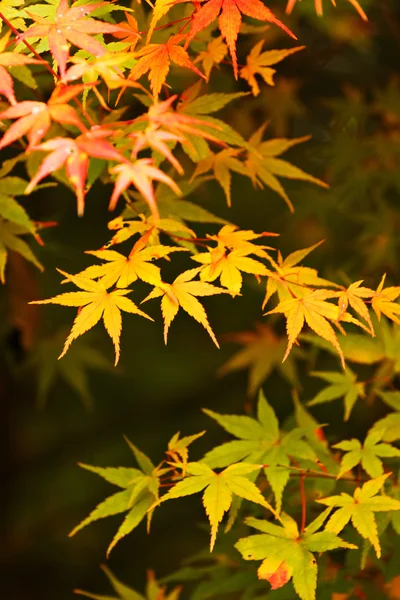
[69,439,170,555]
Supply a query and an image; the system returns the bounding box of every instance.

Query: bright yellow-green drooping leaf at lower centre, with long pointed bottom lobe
[159,462,276,552]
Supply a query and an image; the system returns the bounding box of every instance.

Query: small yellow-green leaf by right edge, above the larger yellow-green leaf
[333,429,400,478]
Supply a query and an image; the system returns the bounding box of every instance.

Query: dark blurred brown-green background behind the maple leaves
[0,0,400,600]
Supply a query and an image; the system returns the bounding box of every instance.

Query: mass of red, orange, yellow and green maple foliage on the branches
[0,0,400,600]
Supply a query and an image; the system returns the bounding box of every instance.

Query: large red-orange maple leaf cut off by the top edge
[186,0,296,79]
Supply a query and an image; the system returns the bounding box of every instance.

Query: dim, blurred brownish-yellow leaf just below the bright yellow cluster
[218,323,297,396]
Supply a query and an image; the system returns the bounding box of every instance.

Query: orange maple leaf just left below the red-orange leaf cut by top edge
[128,35,204,98]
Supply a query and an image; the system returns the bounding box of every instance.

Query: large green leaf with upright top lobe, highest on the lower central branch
[203,391,317,513]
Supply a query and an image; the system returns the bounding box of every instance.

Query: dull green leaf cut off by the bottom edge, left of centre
[74,565,180,600]
